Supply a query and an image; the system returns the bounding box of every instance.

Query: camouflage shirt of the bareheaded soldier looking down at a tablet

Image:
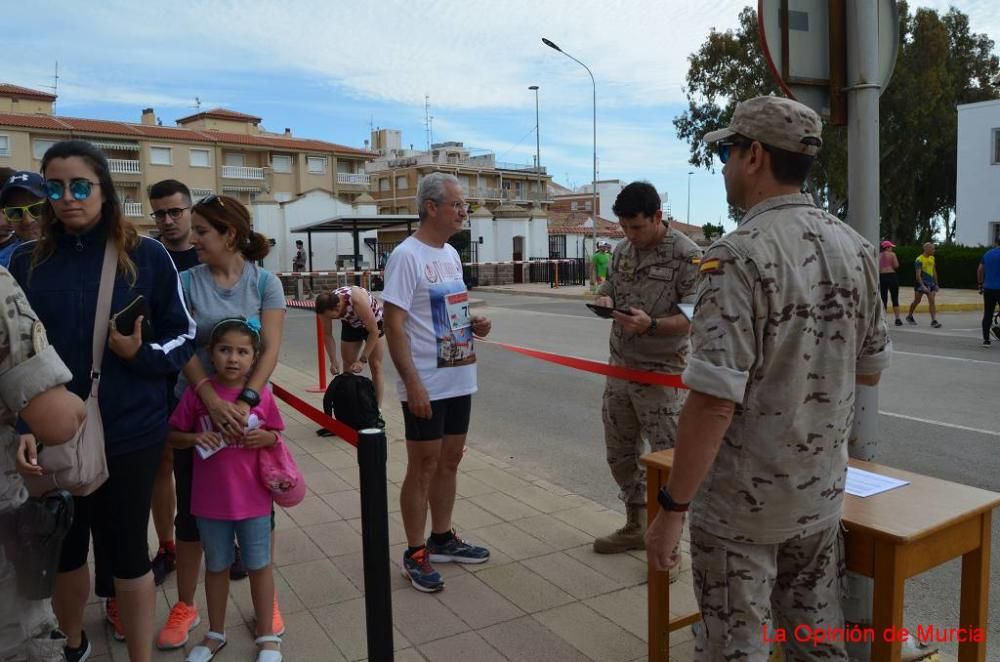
[597,226,701,374]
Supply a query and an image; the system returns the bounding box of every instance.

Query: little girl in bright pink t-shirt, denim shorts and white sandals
[168,318,285,662]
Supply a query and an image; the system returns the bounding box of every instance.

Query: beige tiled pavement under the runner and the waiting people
[85,365,694,662]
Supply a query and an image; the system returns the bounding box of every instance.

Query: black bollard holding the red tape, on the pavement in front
[358,428,393,662]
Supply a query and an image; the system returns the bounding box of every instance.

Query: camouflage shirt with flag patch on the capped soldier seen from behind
[684,195,892,543]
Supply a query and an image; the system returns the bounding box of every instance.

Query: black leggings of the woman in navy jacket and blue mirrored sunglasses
[59,439,164,597]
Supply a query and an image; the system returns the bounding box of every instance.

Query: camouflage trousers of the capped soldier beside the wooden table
[691,522,847,662]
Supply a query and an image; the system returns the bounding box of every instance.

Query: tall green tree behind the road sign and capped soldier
[674,1,1000,242]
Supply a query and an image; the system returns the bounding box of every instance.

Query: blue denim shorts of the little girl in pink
[198,515,271,572]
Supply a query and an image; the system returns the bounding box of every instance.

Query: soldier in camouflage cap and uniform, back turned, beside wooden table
[646,97,891,662]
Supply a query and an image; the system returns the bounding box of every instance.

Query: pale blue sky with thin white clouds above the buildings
[7,0,1000,231]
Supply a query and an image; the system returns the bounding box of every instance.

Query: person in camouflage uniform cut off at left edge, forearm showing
[0,268,84,662]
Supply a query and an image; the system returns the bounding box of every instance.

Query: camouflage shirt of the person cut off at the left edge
[0,268,73,512]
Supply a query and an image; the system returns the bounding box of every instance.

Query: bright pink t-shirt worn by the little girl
[170,379,285,521]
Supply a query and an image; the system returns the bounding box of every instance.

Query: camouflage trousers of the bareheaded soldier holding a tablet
[601,379,687,505]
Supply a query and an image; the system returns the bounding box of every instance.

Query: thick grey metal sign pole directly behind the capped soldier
[844,0,880,659]
